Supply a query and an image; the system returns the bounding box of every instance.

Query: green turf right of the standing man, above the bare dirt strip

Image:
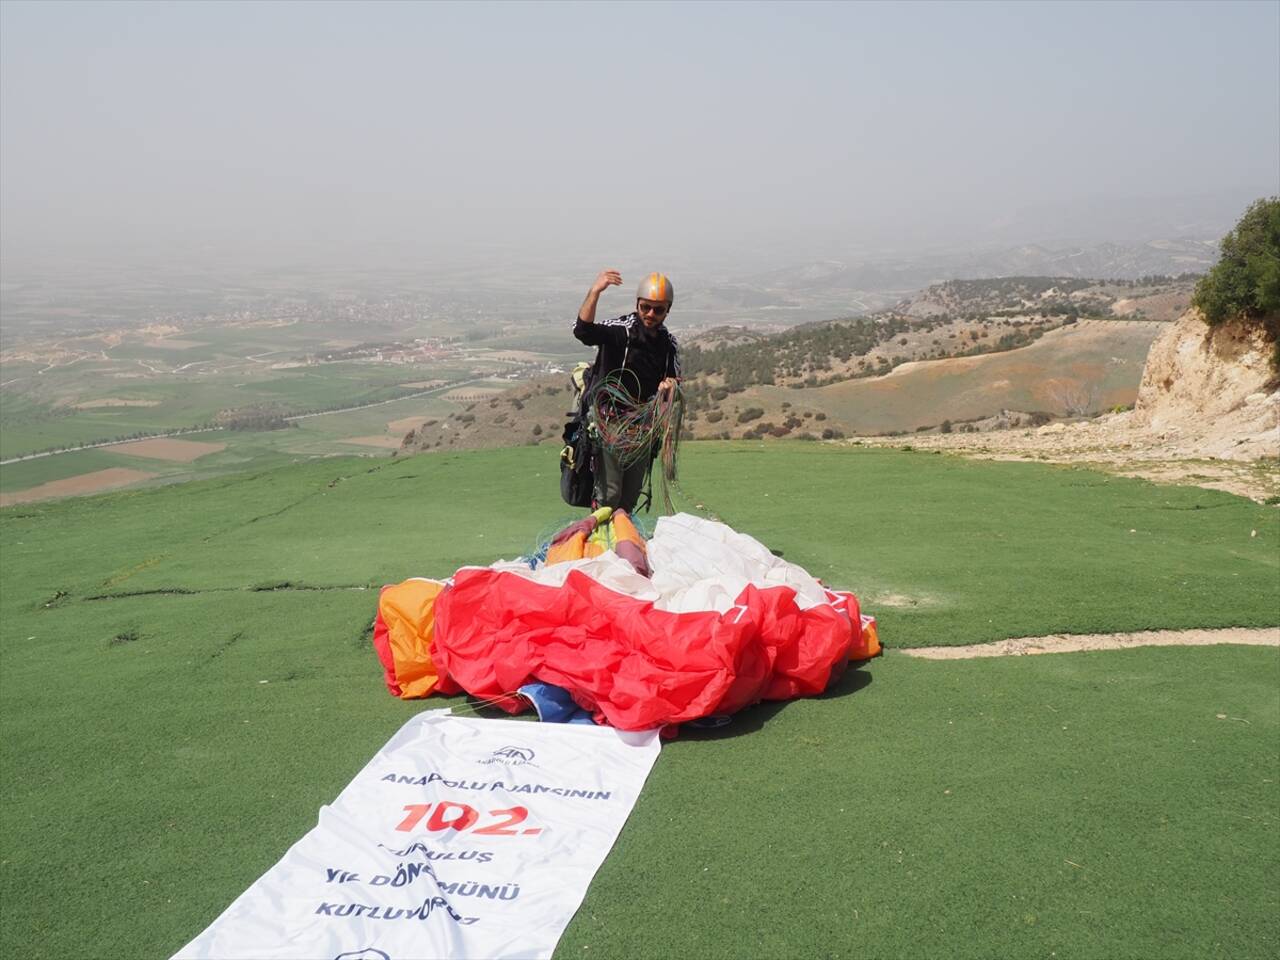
[685,443,1280,646]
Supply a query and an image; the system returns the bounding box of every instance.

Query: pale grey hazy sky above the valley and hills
[0,0,1280,271]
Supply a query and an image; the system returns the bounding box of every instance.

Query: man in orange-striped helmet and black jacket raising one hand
[573,270,680,513]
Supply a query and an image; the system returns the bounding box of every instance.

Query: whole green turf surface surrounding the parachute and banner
[0,445,1280,959]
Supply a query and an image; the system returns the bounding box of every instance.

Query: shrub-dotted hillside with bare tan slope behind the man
[403,275,1194,451]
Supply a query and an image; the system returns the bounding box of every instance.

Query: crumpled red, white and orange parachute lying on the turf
[374,513,879,730]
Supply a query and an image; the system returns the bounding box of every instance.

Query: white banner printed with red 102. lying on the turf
[174,710,659,960]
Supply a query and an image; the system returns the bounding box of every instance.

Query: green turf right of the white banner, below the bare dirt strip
[578,649,1280,957]
